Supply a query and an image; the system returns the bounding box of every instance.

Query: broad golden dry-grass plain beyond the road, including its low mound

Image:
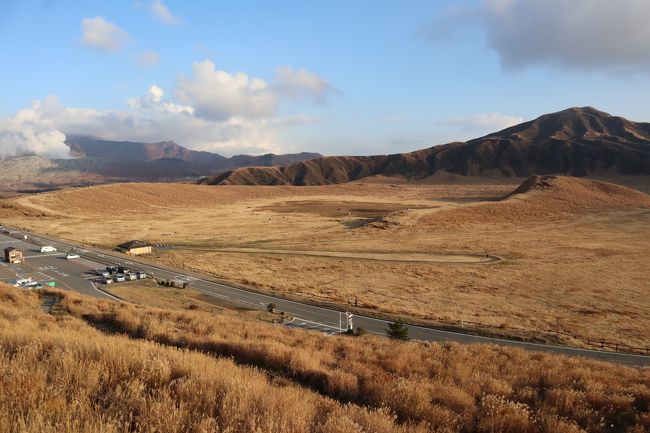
[5,179,650,347]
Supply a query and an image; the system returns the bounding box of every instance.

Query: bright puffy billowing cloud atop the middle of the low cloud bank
[174,60,278,120]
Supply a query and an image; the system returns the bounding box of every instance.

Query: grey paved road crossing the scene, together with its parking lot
[0,226,650,365]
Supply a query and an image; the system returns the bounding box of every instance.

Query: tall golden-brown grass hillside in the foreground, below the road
[0,286,650,433]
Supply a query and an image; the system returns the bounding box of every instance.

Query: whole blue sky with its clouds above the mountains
[0,0,650,157]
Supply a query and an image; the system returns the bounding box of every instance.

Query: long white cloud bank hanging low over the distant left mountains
[0,60,332,157]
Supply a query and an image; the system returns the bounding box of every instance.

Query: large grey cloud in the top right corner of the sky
[481,0,650,71]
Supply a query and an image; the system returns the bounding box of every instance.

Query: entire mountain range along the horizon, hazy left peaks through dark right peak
[0,107,650,191]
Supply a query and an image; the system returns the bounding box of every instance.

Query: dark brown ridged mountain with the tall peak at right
[201,107,650,185]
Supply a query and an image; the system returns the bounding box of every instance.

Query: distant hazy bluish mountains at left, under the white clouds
[0,134,322,191]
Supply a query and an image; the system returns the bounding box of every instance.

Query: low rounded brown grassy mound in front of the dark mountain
[418,176,650,226]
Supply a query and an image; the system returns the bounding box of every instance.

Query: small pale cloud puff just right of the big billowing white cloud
[273,66,333,102]
